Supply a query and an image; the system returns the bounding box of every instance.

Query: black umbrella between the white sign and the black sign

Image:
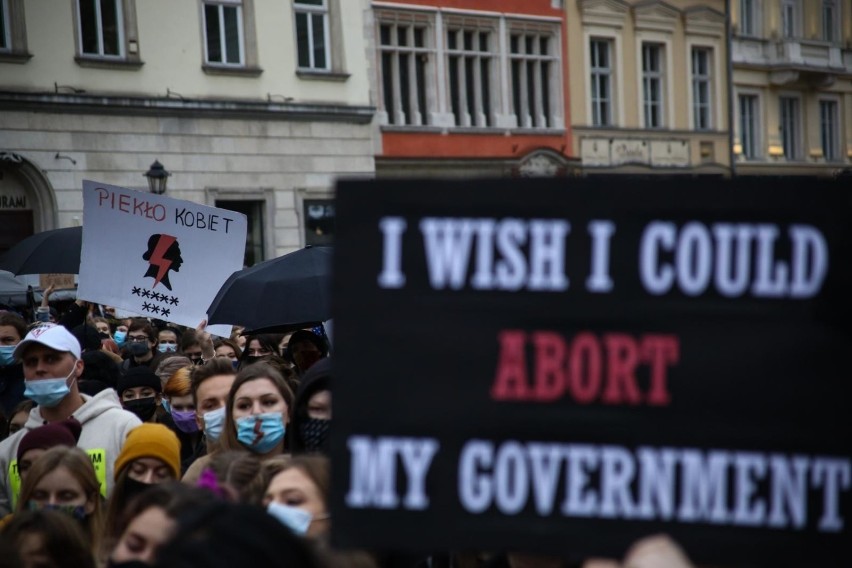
[207,246,332,331]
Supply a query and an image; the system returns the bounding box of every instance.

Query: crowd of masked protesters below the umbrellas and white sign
[0,289,691,568]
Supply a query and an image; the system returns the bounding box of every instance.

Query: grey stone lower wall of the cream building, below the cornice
[0,111,373,258]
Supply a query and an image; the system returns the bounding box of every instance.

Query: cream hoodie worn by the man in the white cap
[0,389,142,514]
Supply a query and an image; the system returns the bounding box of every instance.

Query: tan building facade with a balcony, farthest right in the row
[731,0,852,175]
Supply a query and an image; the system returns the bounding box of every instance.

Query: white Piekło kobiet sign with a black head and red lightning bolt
[77,180,247,337]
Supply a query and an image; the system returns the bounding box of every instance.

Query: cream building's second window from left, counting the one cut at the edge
[77,0,124,58]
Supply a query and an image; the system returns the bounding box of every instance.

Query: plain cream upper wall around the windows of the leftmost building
[5,0,370,105]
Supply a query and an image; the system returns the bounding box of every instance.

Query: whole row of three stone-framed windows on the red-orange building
[376,10,562,129]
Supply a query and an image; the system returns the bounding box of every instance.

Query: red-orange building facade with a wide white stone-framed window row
[368,0,577,177]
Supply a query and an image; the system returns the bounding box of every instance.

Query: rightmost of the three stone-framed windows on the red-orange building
[509,31,557,128]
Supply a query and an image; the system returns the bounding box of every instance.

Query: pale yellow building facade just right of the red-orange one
[566,0,730,175]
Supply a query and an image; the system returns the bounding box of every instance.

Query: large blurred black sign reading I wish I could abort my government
[332,175,852,566]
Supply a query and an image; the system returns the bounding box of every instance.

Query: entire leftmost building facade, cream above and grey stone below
[0,0,375,264]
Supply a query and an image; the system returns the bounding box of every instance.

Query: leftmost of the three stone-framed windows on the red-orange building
[379,22,432,125]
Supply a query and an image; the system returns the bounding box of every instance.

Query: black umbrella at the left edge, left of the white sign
[0,227,83,274]
